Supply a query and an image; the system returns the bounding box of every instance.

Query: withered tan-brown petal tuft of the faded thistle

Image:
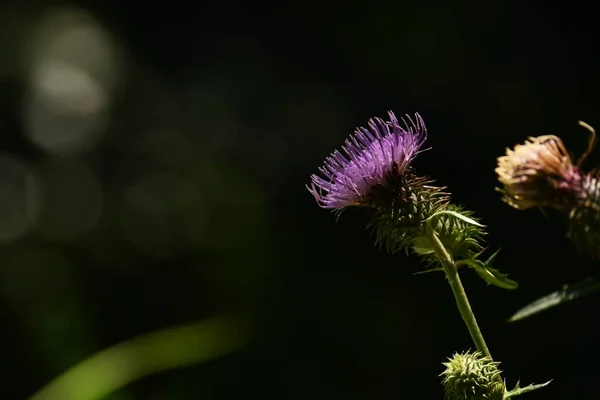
[496,135,582,210]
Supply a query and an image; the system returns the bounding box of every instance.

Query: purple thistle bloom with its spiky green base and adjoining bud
[308,111,482,261]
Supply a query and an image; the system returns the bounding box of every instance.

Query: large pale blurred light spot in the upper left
[23,8,119,154]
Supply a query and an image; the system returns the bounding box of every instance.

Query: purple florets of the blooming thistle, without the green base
[307,111,427,211]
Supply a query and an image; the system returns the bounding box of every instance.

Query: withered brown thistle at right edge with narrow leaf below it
[496,121,600,321]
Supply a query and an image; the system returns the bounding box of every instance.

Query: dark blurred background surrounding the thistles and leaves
[0,0,600,400]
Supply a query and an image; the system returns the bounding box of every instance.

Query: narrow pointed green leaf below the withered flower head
[507,279,600,322]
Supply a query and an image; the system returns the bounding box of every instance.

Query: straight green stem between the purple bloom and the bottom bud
[427,226,492,358]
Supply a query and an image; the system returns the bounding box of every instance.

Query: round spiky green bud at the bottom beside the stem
[440,351,505,400]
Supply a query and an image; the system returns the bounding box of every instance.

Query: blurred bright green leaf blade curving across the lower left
[28,317,246,400]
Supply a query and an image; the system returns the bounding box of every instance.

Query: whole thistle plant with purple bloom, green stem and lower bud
[307,111,549,400]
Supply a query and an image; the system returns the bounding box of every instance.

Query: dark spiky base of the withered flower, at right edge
[567,171,600,259]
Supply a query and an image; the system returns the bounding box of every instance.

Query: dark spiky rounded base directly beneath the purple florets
[368,171,450,253]
